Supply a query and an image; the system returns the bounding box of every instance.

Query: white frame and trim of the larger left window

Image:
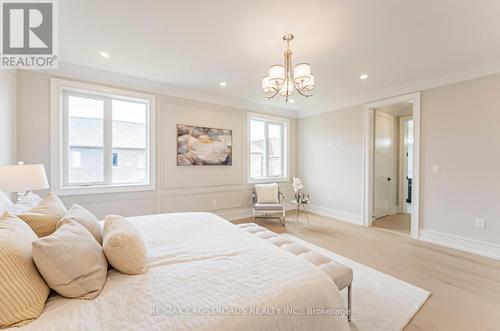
[50,78,156,195]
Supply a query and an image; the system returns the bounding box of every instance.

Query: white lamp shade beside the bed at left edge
[0,162,49,192]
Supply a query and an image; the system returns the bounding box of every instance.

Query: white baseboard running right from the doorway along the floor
[419,229,500,260]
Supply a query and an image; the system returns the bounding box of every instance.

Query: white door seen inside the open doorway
[373,112,395,218]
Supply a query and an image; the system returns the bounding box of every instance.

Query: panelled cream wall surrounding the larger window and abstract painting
[17,68,297,217]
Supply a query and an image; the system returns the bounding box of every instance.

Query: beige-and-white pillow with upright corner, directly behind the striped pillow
[17,192,68,237]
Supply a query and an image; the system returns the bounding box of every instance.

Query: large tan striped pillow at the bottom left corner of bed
[0,213,49,328]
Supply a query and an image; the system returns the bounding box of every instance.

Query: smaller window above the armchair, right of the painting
[248,115,288,182]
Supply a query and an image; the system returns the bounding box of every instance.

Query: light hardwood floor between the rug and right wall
[234,214,500,331]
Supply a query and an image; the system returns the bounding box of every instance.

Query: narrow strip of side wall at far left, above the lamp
[0,70,16,165]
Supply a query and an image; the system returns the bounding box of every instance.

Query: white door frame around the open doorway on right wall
[363,92,421,239]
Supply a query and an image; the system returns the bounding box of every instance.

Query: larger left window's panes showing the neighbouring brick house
[63,91,149,187]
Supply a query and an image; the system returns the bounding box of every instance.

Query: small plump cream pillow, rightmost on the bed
[102,215,147,275]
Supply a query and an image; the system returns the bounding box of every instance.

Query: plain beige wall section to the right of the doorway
[421,75,500,244]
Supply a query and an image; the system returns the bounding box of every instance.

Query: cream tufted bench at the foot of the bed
[236,223,353,321]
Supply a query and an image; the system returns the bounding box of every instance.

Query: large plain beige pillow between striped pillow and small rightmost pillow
[33,219,108,299]
